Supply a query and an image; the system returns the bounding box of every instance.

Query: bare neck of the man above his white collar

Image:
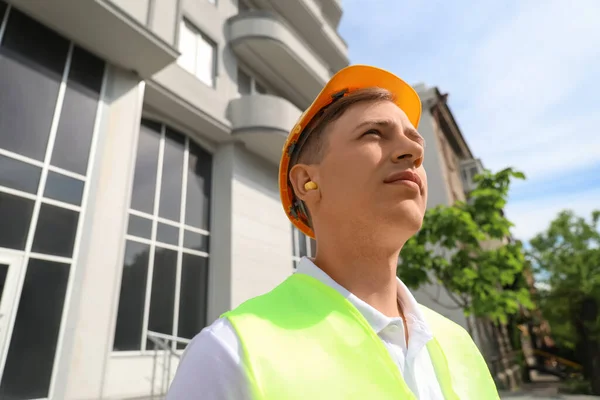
[315,234,402,317]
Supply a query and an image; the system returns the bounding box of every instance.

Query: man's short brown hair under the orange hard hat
[290,87,395,168]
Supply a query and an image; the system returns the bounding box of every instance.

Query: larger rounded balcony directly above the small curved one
[228,11,330,108]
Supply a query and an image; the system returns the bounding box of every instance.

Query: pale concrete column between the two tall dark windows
[53,67,144,400]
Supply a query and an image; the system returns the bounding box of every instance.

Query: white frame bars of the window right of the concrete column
[111,118,215,356]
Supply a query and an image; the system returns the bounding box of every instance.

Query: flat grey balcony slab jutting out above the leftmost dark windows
[10,0,179,78]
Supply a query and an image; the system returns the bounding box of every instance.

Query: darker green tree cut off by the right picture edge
[528,211,600,395]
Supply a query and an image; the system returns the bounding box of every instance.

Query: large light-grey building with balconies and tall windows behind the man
[0,0,348,400]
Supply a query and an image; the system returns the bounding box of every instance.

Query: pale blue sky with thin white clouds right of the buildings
[340,0,600,240]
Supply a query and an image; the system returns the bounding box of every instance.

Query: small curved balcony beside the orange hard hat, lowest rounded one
[228,94,301,164]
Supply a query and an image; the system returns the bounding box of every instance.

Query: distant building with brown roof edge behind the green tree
[414,84,520,389]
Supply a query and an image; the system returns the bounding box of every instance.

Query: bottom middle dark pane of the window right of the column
[147,247,177,340]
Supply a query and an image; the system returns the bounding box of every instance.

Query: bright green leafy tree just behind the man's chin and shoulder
[397,168,532,335]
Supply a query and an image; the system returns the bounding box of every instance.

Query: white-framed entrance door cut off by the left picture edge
[0,250,23,376]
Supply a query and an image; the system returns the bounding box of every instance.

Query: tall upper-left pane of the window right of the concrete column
[131,120,161,214]
